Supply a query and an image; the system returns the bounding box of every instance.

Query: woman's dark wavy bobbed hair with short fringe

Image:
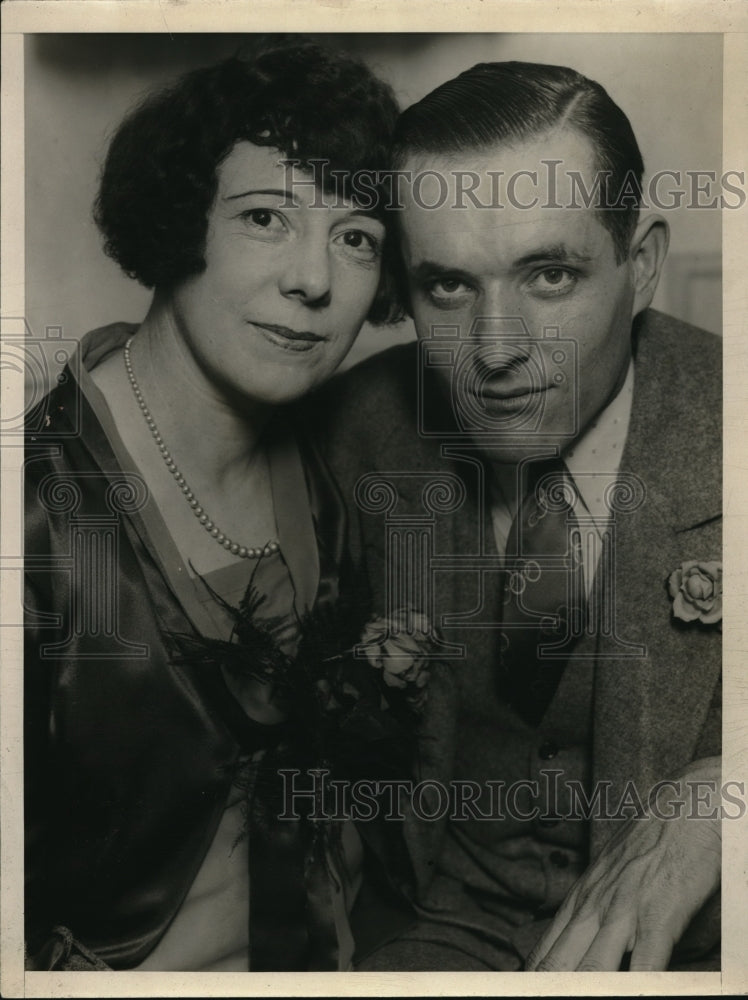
[94,43,410,323]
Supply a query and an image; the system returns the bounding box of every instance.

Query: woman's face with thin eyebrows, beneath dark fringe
[172,142,384,404]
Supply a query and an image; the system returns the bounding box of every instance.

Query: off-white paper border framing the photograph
[0,0,748,997]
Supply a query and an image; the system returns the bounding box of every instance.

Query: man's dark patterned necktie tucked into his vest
[500,458,586,726]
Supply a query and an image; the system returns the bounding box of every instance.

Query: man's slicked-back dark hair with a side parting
[393,62,644,263]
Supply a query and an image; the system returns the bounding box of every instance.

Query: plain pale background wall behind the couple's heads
[25,34,720,378]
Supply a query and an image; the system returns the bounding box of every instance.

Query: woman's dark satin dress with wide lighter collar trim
[25,324,380,971]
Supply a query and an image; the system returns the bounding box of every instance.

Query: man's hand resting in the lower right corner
[527,757,722,972]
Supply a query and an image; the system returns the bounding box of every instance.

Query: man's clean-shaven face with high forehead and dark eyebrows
[401,129,634,462]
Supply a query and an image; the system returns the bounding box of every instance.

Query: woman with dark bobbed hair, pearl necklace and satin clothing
[26,45,418,971]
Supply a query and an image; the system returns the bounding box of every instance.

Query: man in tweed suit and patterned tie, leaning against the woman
[308,63,721,970]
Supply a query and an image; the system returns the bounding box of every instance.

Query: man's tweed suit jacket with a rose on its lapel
[309,310,722,928]
